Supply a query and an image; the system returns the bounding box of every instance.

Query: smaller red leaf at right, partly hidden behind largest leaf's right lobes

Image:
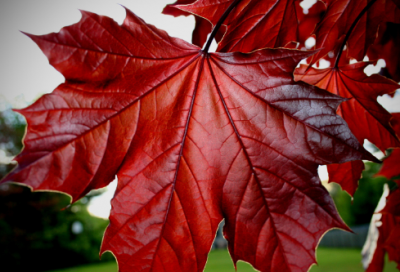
[295,62,400,195]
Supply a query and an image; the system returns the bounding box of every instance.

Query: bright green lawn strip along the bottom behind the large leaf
[52,248,398,272]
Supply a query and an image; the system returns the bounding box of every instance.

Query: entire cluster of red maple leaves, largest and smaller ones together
[2,0,400,271]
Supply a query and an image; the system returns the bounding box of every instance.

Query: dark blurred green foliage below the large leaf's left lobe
[0,184,112,272]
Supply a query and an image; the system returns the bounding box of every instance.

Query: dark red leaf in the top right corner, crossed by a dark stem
[311,0,400,64]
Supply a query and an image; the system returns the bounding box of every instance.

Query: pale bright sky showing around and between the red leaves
[0,0,400,218]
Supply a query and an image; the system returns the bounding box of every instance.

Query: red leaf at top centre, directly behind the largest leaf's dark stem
[176,0,298,52]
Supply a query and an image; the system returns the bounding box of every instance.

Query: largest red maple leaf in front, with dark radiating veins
[3,7,374,271]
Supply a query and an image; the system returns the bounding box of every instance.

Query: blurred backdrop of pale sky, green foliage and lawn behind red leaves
[0,0,400,272]
